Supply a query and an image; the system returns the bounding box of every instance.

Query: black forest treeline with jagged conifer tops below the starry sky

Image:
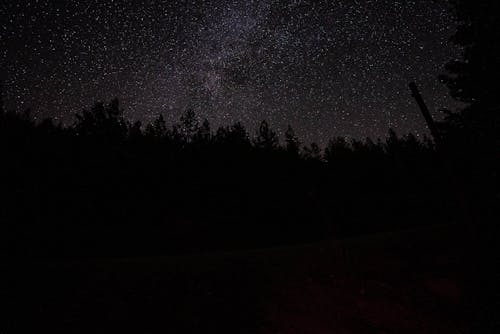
[0,100,460,256]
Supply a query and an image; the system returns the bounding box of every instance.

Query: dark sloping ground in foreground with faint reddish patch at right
[4,225,471,334]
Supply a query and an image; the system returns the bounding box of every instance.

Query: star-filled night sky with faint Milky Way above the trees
[0,0,460,144]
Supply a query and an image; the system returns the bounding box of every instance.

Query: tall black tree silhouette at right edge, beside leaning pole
[440,0,500,235]
